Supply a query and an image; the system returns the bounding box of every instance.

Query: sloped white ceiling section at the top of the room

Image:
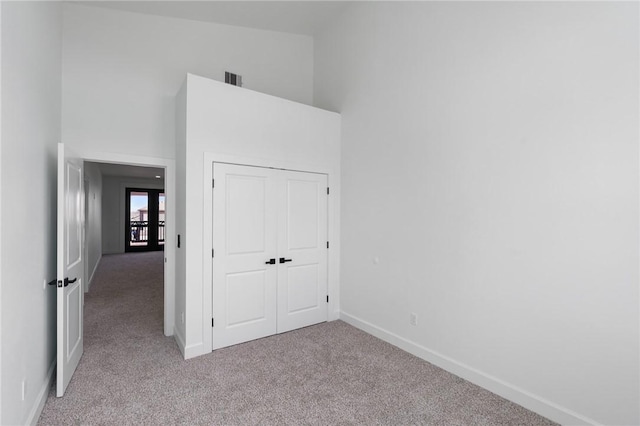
[73,0,350,35]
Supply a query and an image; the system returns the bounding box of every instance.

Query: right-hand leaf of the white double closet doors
[278,171,328,333]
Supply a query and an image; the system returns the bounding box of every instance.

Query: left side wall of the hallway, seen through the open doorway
[84,161,102,291]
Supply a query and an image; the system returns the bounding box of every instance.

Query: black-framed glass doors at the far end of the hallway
[124,188,165,252]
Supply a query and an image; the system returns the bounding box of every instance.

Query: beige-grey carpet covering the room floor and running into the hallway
[39,252,554,425]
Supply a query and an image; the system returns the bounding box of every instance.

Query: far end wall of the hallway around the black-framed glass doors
[102,176,164,254]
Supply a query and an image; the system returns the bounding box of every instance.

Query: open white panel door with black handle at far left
[56,144,84,396]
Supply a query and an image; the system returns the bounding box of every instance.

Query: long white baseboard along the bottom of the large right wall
[340,312,599,425]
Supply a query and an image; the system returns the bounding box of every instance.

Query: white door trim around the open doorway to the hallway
[77,150,176,336]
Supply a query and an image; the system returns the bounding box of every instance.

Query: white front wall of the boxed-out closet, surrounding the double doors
[176,74,340,358]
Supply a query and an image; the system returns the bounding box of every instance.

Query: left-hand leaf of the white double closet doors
[213,163,278,349]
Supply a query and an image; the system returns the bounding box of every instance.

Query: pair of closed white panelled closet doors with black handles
[213,163,328,349]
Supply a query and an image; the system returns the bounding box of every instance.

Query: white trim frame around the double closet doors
[202,152,340,353]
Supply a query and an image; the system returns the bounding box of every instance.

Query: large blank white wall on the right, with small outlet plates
[315,2,640,424]
